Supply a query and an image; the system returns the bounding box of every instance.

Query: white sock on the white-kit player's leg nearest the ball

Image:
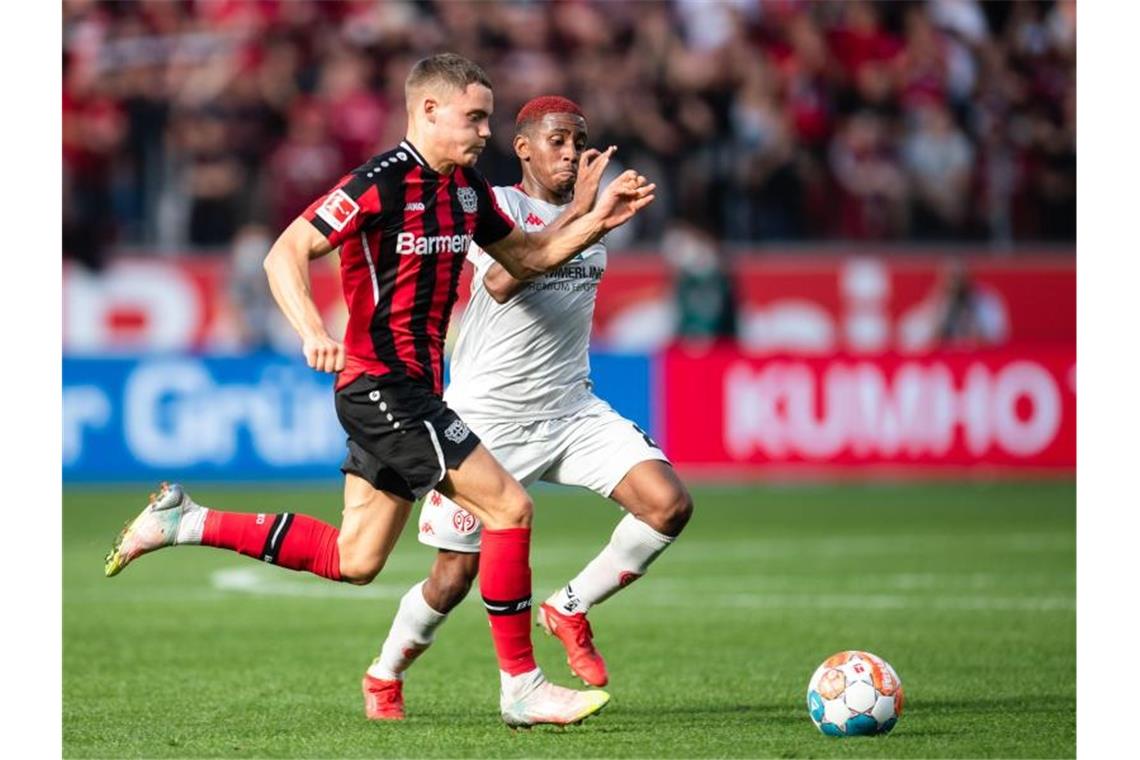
[547,515,674,615]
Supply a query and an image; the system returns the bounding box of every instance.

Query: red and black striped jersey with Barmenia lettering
[303,140,514,395]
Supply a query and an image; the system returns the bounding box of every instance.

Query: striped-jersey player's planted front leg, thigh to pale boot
[438,446,610,727]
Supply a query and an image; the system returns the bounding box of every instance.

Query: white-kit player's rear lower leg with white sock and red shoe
[365,549,479,720]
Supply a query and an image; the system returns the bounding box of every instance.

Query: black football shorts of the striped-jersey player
[336,375,479,501]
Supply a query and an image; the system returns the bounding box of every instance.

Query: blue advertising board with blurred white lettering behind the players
[63,353,650,482]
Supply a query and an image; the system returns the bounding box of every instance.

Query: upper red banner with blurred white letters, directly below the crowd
[63,252,1076,356]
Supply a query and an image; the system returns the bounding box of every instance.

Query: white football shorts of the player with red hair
[420,398,669,554]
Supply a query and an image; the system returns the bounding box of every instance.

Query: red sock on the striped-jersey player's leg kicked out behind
[202,509,341,581]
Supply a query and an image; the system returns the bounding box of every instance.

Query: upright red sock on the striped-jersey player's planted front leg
[479,528,538,676]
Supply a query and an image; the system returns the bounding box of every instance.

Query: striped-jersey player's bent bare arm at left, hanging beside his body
[263,216,344,373]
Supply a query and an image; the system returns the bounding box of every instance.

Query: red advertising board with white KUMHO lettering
[657,346,1076,476]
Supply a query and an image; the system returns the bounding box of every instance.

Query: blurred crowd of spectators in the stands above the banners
[63,0,1076,268]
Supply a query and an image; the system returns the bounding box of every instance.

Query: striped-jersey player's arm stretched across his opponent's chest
[483,170,657,280]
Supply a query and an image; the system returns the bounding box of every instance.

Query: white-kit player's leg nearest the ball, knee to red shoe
[537,460,693,686]
